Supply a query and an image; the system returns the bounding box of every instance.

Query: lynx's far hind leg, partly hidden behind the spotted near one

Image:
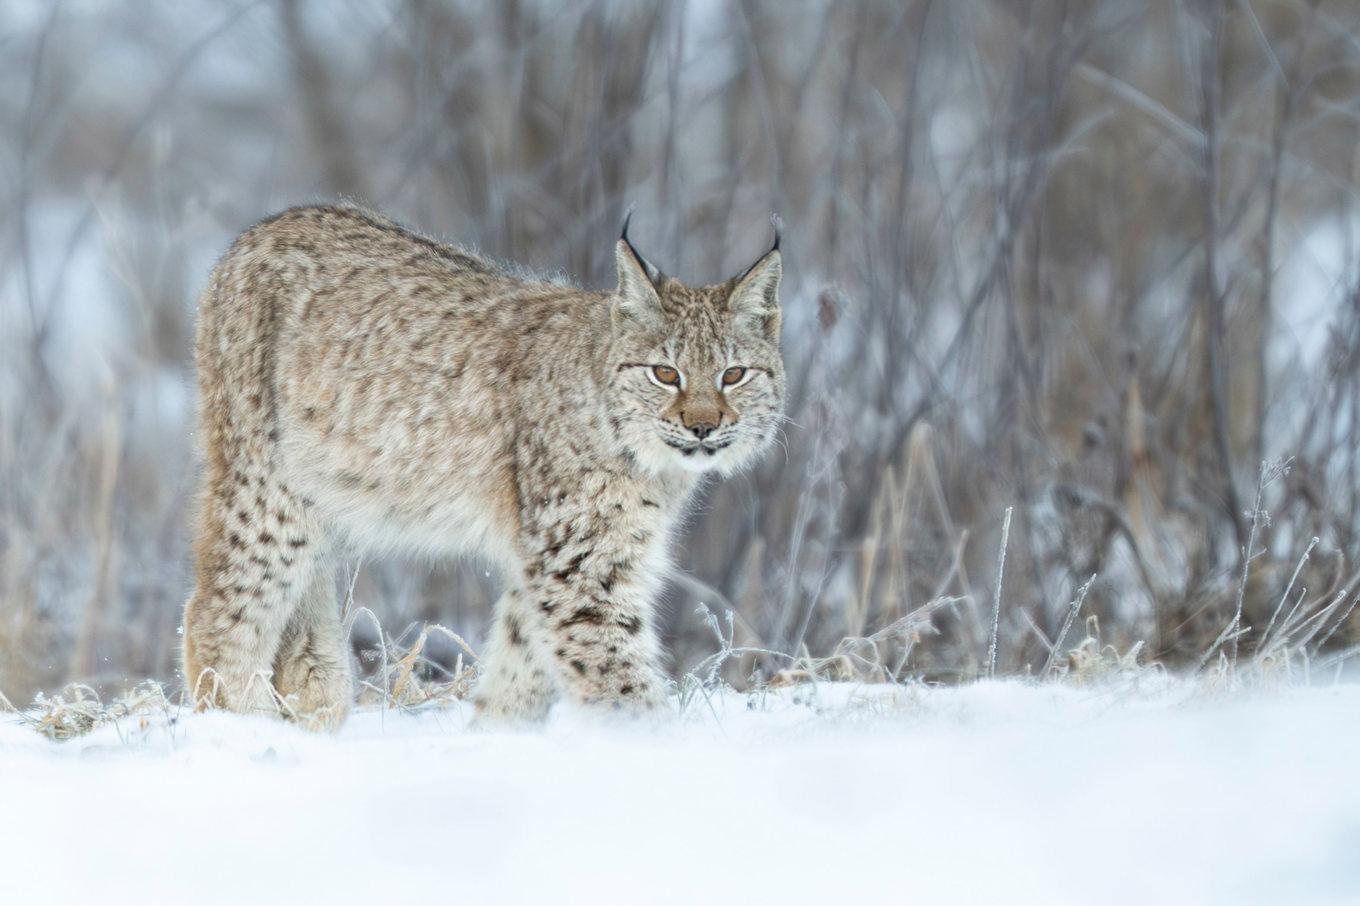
[273,562,354,731]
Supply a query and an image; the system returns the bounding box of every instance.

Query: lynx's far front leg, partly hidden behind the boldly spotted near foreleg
[475,592,558,724]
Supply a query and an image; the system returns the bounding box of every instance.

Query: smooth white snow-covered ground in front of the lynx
[0,675,1360,906]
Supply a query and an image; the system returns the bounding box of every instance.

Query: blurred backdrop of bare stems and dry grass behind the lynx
[0,0,1360,702]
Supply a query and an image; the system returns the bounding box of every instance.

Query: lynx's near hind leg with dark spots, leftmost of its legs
[184,468,321,714]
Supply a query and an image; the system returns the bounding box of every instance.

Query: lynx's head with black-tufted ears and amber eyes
[608,222,783,475]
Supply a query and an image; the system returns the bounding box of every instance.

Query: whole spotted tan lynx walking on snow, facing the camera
[184,207,785,726]
